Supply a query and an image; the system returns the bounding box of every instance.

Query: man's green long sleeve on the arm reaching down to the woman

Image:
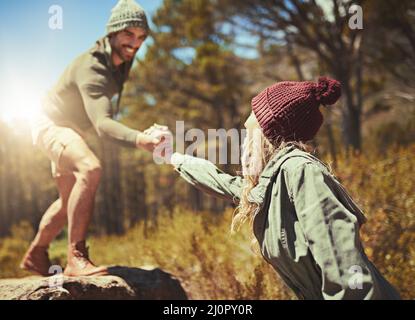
[79,71,138,148]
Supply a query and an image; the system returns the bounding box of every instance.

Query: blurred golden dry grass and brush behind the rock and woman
[0,145,415,299]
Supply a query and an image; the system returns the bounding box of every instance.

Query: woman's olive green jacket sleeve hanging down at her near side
[289,163,375,300]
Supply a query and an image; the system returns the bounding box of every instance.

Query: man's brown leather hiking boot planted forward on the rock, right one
[63,241,108,277]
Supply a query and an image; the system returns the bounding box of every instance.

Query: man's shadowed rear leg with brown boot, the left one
[20,175,75,276]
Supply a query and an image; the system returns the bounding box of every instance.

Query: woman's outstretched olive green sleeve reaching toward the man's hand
[172,153,243,202]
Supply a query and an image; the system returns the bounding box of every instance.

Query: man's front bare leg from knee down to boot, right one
[59,140,107,276]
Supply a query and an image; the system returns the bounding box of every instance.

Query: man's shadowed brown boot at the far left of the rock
[20,245,52,277]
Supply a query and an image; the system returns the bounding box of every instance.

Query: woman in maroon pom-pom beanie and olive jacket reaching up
[154,78,399,299]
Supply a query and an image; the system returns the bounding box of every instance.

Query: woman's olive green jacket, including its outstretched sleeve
[172,146,399,300]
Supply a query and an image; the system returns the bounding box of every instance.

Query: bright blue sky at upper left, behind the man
[0,0,162,122]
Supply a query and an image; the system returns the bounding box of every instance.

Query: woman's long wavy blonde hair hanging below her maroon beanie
[231,130,310,236]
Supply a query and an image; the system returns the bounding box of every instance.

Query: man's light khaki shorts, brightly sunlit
[32,116,84,178]
